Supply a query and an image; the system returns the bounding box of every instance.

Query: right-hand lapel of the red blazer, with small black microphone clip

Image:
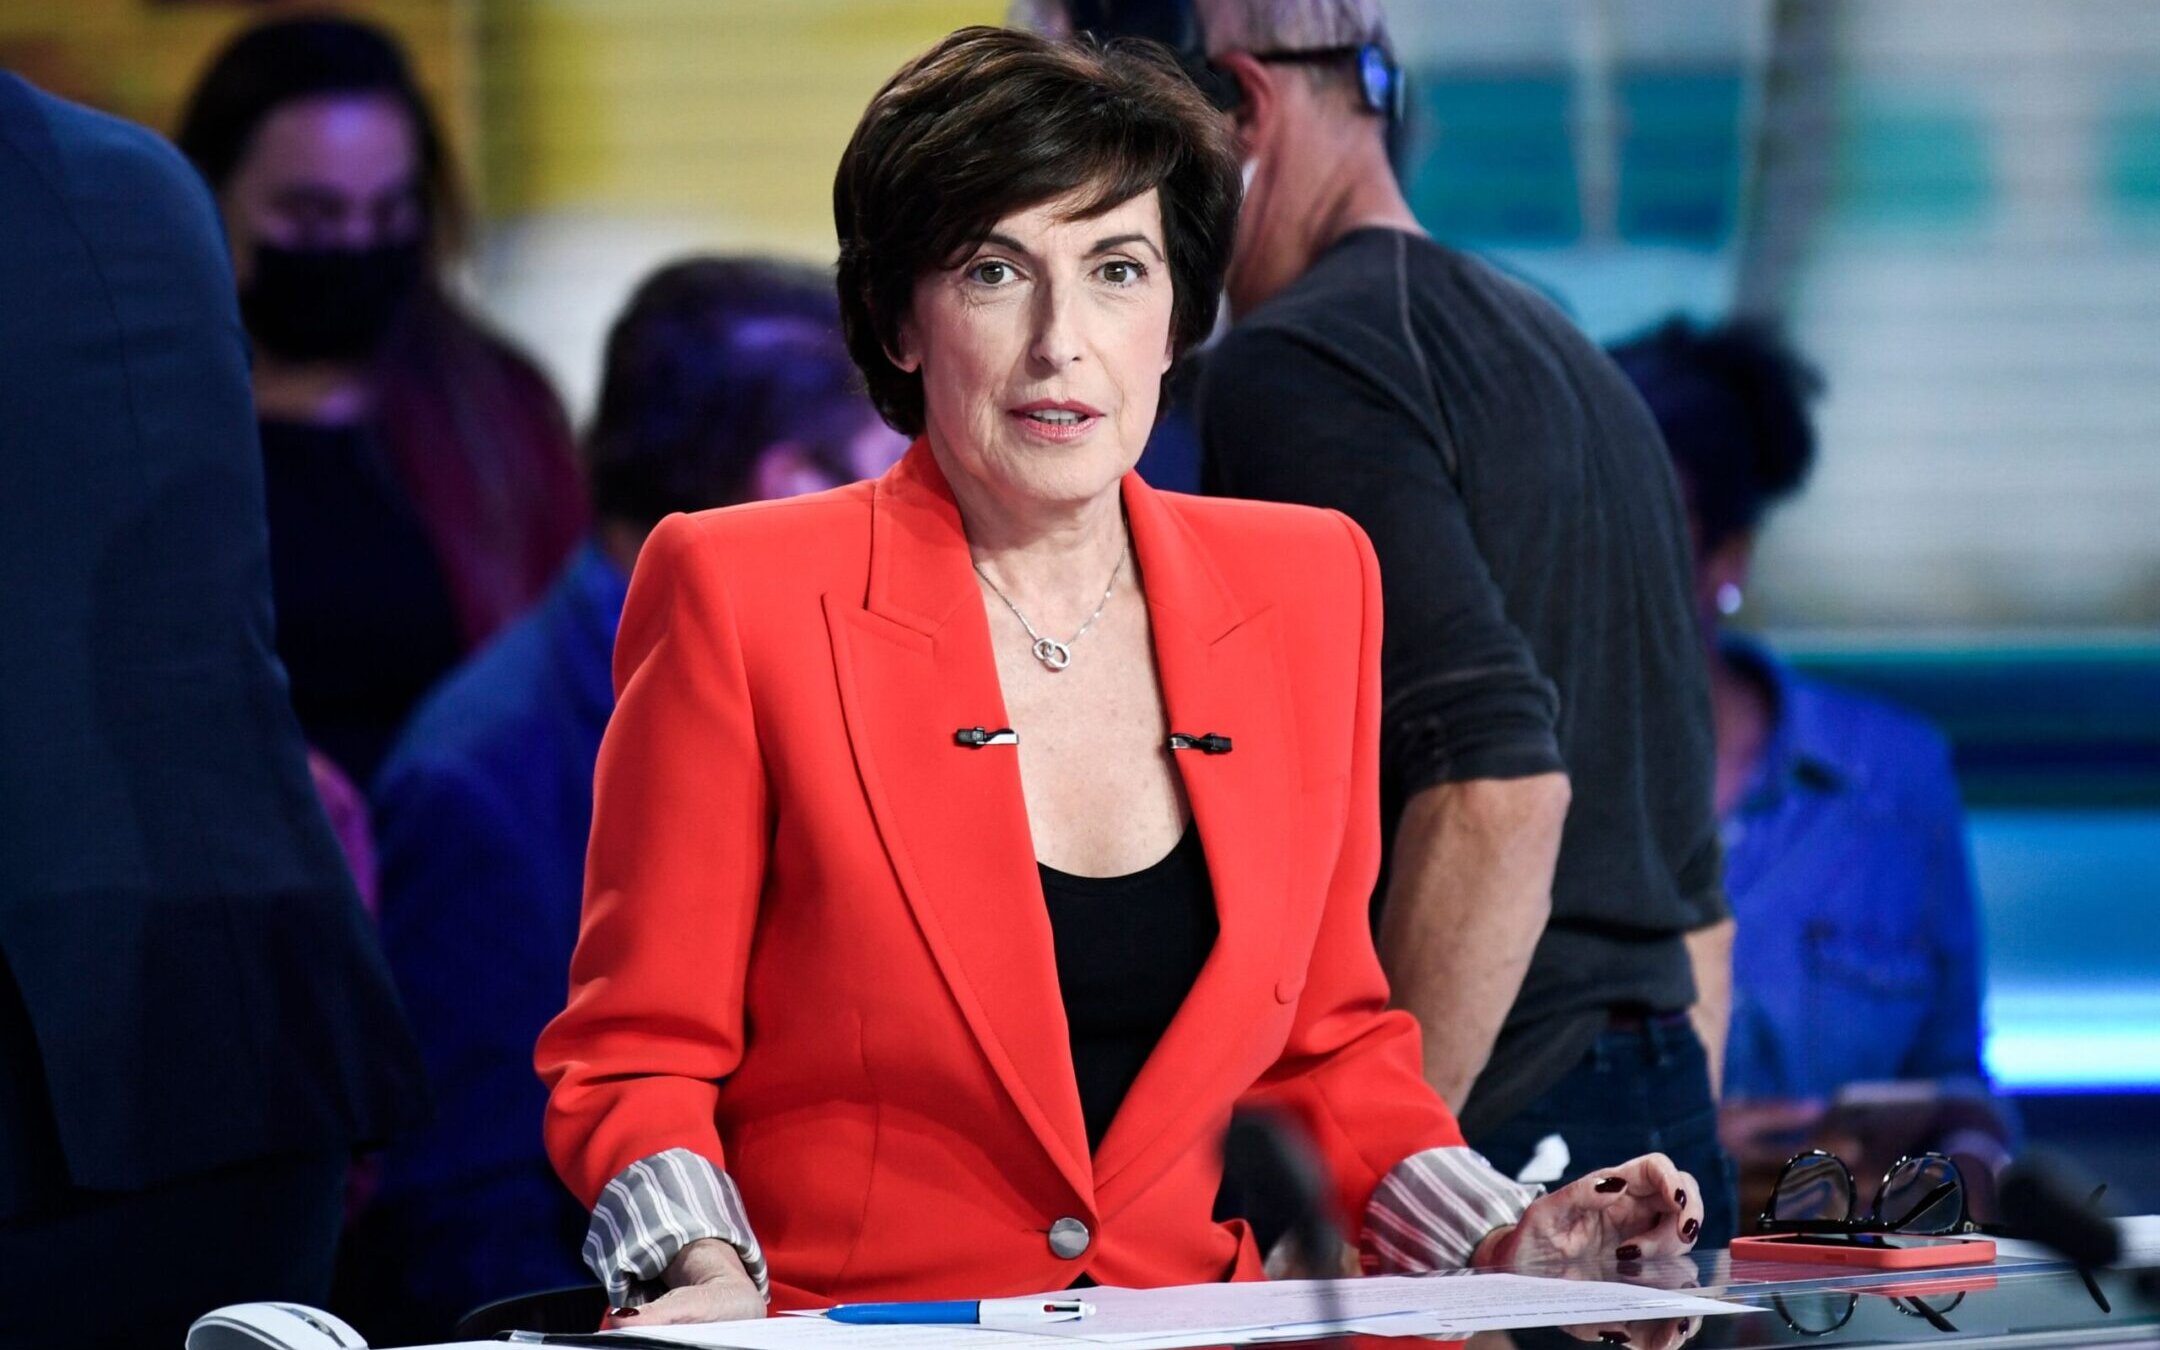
[1095,475,1298,1214]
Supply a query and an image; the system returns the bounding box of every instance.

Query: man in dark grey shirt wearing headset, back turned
[1032,0,1734,1246]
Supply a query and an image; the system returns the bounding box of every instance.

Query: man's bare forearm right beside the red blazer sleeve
[1380,773,1568,1110]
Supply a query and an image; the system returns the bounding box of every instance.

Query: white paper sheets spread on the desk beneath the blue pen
[596,1274,1758,1350]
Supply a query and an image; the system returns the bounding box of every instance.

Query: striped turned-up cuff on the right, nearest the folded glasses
[1359,1147,1544,1274]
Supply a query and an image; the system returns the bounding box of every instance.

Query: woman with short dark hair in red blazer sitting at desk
[538,28,1702,1326]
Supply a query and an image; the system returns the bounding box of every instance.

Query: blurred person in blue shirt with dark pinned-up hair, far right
[1614,320,2009,1218]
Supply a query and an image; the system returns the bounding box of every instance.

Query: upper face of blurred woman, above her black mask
[220,93,426,289]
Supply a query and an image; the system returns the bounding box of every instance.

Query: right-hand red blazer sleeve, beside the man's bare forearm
[1246,514,1462,1231]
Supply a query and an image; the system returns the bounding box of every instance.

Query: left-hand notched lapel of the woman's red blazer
[825,441,1093,1197]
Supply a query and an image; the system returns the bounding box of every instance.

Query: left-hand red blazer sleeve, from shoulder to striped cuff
[536,516,771,1207]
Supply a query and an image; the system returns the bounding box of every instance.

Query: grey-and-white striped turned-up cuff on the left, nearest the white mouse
[583,1149,771,1307]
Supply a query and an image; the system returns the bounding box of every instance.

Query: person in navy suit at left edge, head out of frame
[0,71,426,1346]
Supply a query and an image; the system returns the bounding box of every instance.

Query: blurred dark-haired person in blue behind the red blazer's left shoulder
[354,257,905,1339]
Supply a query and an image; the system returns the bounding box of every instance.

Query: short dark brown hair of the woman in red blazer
[832,28,1240,436]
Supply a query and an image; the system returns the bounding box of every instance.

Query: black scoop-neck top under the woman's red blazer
[1037,825,1216,1149]
